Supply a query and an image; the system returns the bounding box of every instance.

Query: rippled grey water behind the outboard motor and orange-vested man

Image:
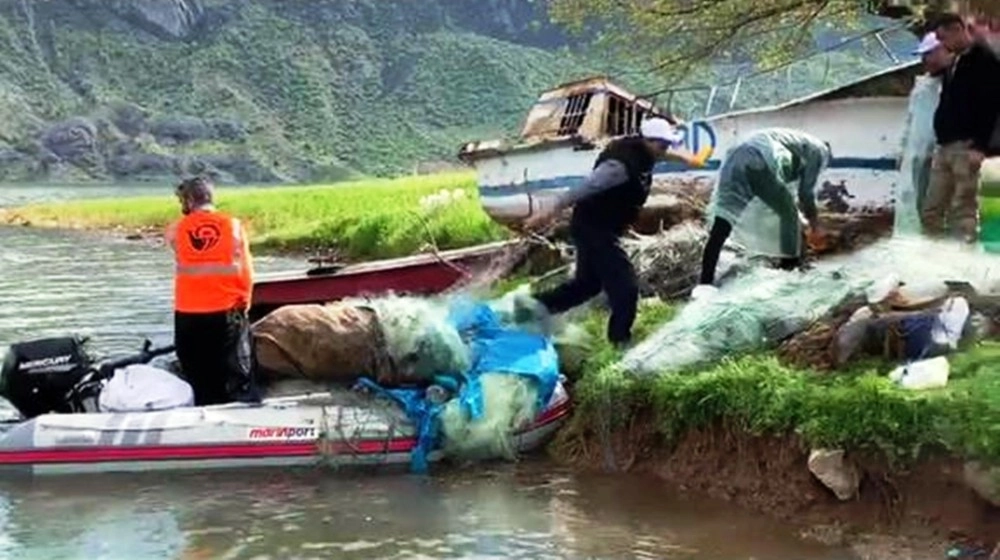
[0,227,302,351]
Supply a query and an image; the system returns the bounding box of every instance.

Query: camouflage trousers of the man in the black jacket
[920,142,980,243]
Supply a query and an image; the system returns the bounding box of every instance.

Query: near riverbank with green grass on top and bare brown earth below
[550,303,1000,546]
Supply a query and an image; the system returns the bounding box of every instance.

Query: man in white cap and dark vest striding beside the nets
[525,118,709,347]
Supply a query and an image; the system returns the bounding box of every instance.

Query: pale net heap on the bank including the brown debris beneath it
[619,238,1000,375]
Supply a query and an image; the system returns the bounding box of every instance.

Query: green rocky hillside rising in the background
[0,0,916,183]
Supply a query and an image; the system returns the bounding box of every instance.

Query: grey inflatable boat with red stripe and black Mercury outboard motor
[0,339,570,476]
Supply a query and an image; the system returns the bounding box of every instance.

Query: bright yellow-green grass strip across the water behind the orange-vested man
[0,173,505,261]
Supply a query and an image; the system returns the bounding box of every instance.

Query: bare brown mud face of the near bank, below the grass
[550,419,1000,560]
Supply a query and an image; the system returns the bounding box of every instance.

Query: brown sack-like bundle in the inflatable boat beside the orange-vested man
[252,304,387,382]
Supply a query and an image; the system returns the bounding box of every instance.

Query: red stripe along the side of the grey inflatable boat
[0,400,570,465]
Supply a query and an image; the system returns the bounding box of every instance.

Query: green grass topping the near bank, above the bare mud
[562,304,1000,464]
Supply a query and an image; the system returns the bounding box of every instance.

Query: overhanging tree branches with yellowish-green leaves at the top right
[549,0,1000,78]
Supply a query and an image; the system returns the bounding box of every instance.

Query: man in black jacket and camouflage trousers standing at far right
[921,14,1000,243]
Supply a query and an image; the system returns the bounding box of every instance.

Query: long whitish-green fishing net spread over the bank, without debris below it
[618,237,1000,374]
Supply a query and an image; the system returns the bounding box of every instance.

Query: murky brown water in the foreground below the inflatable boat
[0,464,852,560]
